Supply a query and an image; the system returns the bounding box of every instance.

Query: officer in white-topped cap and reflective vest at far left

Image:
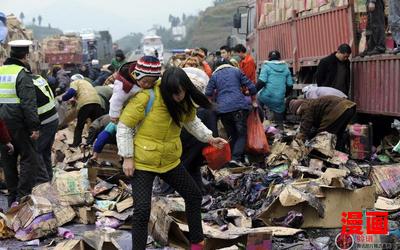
[0,40,48,205]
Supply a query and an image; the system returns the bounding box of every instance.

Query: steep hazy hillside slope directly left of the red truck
[187,0,247,50]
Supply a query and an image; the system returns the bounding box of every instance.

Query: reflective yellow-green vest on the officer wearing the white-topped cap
[0,65,24,104]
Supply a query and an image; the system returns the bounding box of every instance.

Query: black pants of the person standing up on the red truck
[367,0,386,51]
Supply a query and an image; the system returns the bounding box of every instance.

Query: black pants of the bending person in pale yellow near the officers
[73,103,104,147]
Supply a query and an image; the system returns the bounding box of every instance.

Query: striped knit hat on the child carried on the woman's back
[134,56,161,80]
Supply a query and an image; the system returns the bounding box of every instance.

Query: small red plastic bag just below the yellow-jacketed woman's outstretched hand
[202,143,231,170]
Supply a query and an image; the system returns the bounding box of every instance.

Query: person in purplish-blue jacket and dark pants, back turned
[205,58,258,166]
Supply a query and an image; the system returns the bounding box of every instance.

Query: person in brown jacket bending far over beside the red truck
[289,96,356,151]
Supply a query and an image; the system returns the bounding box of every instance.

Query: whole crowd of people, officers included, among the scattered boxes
[0,38,355,249]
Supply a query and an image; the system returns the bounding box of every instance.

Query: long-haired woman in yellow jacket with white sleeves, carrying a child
[117,67,227,250]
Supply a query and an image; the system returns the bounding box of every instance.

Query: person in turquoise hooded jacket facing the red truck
[257,50,293,130]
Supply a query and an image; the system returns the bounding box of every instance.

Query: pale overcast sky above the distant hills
[0,0,213,40]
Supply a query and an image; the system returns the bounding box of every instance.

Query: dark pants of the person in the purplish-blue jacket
[221,110,249,161]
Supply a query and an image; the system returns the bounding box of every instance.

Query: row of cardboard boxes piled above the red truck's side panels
[259,0,348,28]
